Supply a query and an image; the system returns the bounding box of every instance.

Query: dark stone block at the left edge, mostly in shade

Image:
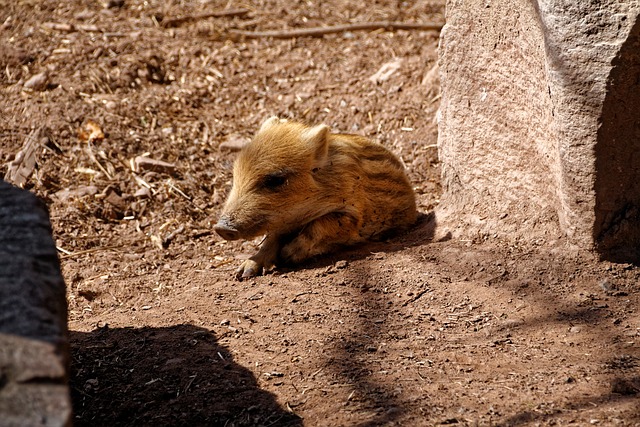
[0,181,71,426]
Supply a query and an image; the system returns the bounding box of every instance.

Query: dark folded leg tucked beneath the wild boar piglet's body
[280,212,364,264]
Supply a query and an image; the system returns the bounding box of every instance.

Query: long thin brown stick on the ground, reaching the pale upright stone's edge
[229,21,442,39]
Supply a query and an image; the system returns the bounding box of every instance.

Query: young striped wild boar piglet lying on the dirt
[214,117,417,279]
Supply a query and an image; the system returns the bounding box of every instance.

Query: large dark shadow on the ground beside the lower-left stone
[70,325,302,427]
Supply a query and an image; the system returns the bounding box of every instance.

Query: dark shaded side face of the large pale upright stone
[593,15,640,263]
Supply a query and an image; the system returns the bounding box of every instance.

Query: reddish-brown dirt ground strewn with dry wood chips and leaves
[0,0,640,426]
